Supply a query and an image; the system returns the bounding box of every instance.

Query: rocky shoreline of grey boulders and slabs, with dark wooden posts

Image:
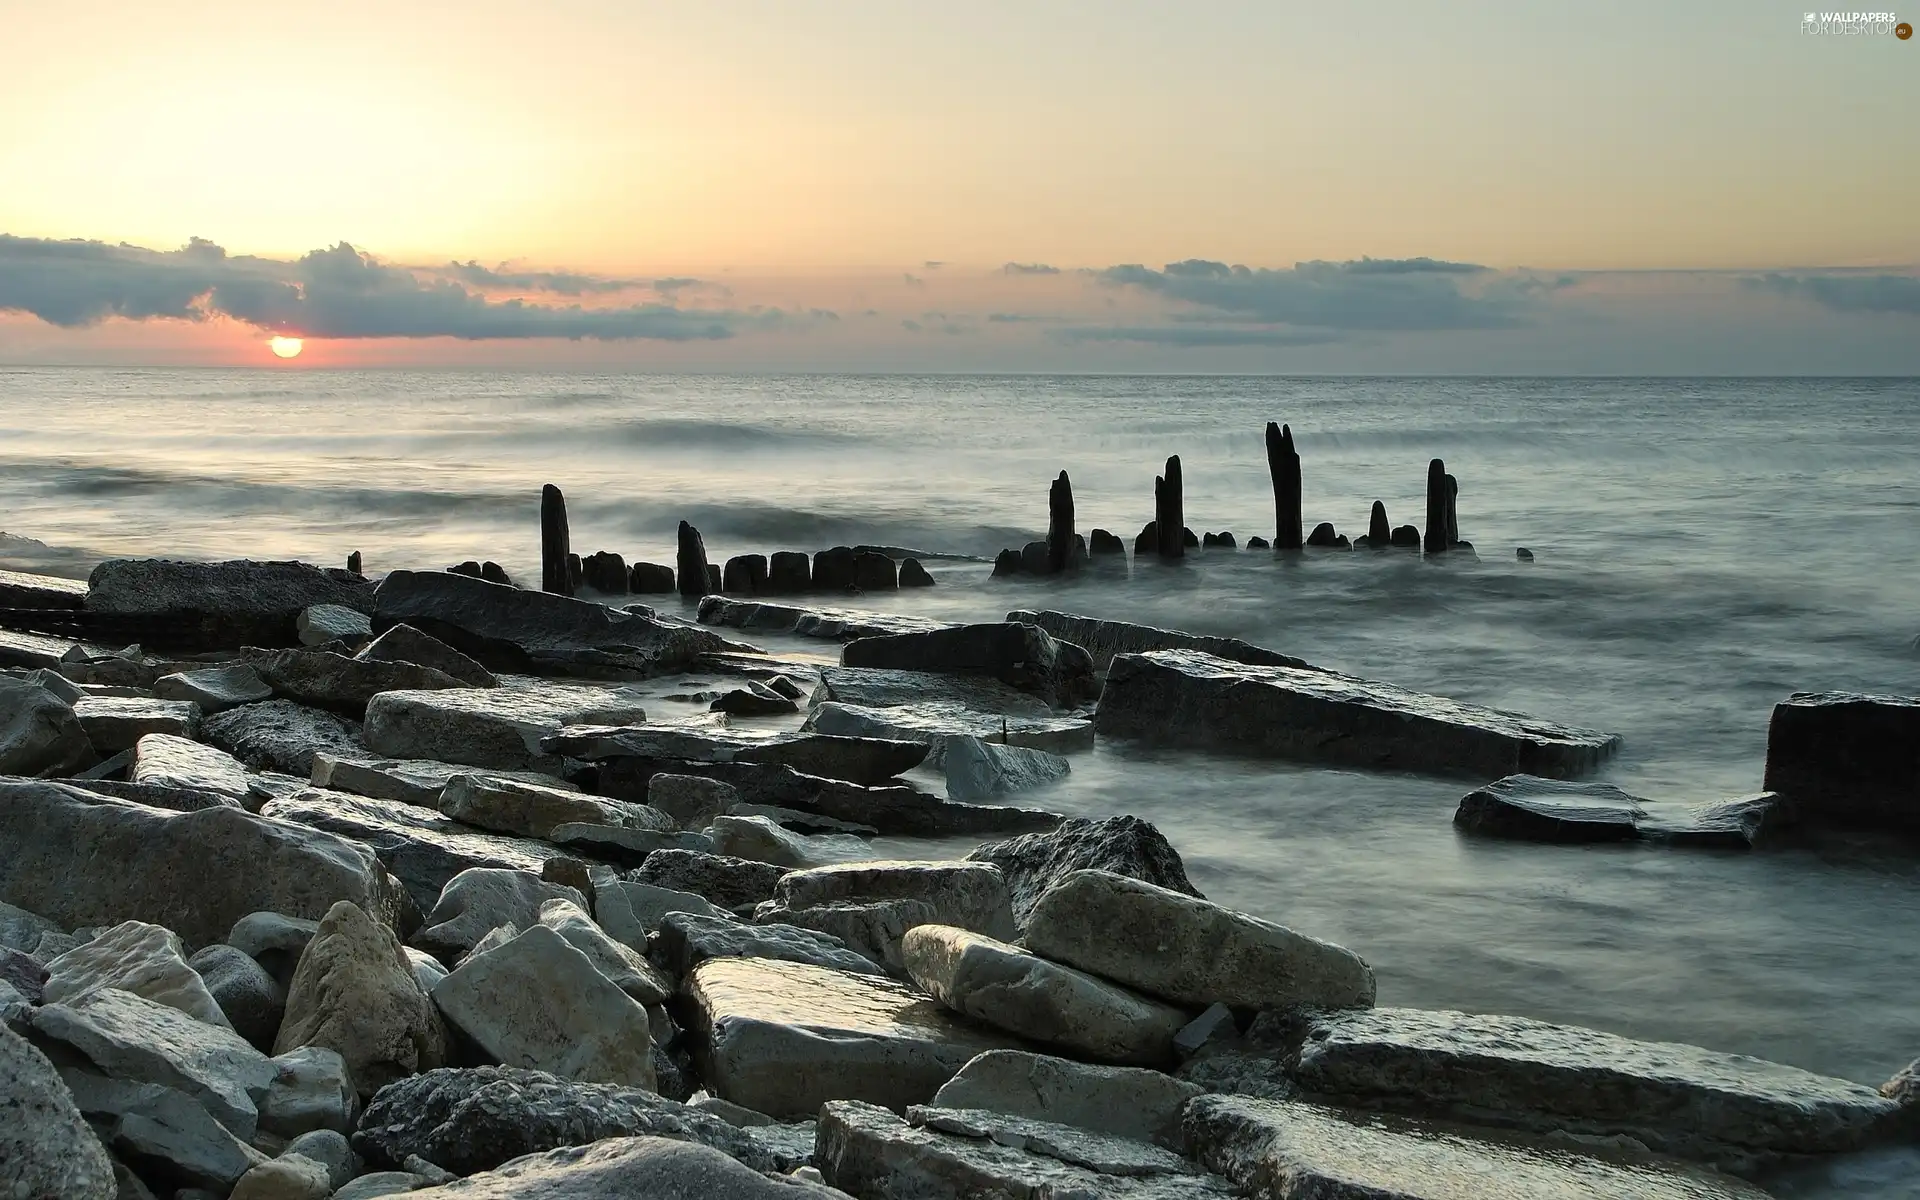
[0,552,1920,1200]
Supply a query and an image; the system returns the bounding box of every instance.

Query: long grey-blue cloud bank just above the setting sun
[0,234,779,342]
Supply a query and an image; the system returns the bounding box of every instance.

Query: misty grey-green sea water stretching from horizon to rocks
[0,371,1920,1196]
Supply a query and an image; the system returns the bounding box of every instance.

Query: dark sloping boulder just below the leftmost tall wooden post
[372,570,724,679]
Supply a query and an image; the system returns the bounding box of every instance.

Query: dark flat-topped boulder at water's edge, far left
[86,559,372,647]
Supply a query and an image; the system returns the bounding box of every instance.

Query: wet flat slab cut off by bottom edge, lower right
[1185,1096,1766,1200]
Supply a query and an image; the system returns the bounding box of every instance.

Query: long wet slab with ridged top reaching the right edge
[1298,1008,1897,1160]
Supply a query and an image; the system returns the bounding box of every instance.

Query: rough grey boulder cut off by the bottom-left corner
[0,1023,117,1200]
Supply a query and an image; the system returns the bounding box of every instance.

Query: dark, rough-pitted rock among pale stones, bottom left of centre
[353,1068,774,1194]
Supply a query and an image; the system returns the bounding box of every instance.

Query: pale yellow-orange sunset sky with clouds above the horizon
[0,0,1920,374]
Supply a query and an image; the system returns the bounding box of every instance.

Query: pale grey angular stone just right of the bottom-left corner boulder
[33,987,273,1140]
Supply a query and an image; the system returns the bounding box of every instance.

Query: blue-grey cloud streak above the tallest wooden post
[1094,259,1526,332]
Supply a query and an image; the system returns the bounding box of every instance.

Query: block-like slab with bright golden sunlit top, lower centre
[685,958,1021,1117]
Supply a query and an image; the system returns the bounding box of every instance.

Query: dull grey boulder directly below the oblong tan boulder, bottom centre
[933,1050,1200,1150]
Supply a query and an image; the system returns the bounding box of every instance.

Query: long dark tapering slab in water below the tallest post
[1094,651,1620,778]
